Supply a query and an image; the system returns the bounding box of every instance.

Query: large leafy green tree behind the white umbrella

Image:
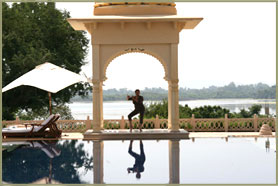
[2,3,88,120]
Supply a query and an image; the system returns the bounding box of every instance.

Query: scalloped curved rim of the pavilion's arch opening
[101,45,169,81]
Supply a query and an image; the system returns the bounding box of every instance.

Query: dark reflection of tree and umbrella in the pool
[2,141,93,183]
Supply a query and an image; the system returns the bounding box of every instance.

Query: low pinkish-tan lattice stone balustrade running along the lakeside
[2,115,275,133]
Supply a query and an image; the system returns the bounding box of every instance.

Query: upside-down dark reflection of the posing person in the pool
[127,140,146,179]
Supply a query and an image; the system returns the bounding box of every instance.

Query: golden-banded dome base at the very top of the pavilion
[94,2,177,15]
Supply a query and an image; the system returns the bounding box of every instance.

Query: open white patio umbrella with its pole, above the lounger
[2,62,88,114]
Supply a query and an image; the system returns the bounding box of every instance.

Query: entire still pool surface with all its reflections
[2,138,276,184]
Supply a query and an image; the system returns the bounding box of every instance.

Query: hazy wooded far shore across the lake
[71,83,276,102]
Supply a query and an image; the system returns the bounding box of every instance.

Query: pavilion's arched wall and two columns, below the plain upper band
[92,42,179,132]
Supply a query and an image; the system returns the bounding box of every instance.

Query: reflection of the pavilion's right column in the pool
[169,140,180,184]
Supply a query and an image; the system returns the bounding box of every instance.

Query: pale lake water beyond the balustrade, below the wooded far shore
[69,99,276,119]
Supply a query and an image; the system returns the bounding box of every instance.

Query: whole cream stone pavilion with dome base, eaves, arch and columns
[68,2,203,132]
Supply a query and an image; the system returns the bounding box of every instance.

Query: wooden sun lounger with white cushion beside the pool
[2,114,62,138]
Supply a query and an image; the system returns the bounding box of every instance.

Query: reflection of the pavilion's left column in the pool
[93,141,103,184]
